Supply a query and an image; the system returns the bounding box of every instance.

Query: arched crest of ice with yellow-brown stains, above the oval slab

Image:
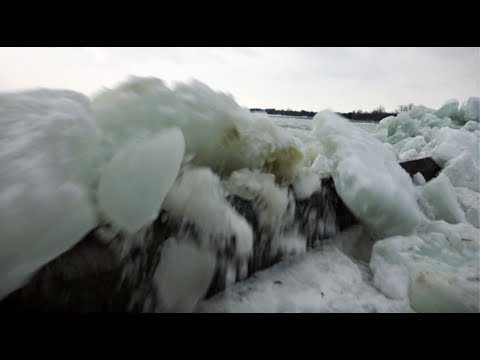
[93,77,300,180]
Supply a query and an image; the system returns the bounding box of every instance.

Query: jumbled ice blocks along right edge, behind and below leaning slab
[370,97,480,312]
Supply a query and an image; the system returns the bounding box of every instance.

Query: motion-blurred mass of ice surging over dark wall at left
[0,77,302,306]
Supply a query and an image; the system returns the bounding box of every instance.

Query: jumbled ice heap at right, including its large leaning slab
[314,98,480,312]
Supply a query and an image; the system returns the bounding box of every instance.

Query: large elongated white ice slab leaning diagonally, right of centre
[313,111,425,238]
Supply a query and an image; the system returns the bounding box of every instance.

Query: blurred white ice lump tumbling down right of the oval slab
[163,168,253,258]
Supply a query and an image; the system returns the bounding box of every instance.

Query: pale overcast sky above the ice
[0,48,480,111]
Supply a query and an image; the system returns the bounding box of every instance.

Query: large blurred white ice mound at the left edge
[0,90,100,298]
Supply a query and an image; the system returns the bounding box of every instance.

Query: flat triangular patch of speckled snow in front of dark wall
[196,246,411,313]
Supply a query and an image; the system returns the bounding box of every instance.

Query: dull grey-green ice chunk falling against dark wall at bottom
[154,238,216,312]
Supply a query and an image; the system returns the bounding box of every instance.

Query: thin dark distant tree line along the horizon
[250,104,413,121]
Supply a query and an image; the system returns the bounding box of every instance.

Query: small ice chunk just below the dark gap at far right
[417,174,466,224]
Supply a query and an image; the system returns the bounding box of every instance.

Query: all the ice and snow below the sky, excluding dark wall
[0,78,480,312]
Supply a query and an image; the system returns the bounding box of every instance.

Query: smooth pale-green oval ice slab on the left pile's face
[98,128,185,233]
